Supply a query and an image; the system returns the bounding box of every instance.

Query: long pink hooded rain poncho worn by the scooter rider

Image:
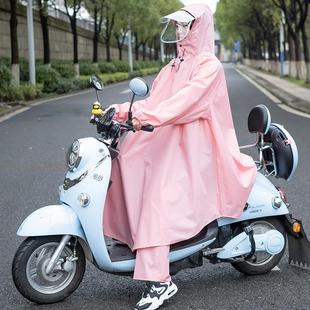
[104,5,256,250]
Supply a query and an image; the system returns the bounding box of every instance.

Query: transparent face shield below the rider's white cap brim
[160,19,192,43]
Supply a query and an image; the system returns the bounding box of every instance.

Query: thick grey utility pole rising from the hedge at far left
[27,0,36,85]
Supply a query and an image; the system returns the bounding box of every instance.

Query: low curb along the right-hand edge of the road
[237,66,310,114]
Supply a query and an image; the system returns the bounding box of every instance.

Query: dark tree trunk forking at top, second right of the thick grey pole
[64,0,82,75]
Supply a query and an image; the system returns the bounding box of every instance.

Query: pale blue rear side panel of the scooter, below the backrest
[217,172,289,227]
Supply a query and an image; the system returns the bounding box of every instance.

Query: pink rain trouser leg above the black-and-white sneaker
[133,245,171,282]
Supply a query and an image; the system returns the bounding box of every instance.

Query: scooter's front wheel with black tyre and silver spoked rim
[12,236,85,304]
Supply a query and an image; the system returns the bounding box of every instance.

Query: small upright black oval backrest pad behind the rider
[248,104,271,134]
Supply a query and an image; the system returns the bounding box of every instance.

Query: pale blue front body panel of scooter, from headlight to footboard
[60,138,115,272]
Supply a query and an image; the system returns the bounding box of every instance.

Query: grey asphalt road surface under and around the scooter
[0,66,310,310]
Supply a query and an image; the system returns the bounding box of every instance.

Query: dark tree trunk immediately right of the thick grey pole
[37,0,50,64]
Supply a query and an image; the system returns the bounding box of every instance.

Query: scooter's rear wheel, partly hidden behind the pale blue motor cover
[231,218,286,275]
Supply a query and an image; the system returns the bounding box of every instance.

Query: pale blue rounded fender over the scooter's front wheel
[17,204,86,242]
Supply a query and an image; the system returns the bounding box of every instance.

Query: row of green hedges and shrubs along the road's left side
[0,59,159,102]
